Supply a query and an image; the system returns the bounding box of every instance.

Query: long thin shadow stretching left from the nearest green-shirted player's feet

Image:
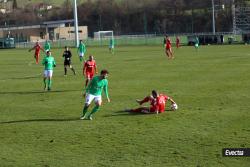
[0,117,80,124]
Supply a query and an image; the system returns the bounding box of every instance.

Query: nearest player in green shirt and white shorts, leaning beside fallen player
[80,70,110,120]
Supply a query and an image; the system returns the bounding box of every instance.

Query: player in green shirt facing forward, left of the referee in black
[42,51,56,91]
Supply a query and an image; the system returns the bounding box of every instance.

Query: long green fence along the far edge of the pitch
[16,33,243,48]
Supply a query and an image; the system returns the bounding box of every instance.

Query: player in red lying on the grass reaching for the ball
[125,90,176,114]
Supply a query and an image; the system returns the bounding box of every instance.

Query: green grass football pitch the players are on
[0,45,250,167]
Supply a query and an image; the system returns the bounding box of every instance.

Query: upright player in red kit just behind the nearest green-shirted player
[83,55,98,87]
